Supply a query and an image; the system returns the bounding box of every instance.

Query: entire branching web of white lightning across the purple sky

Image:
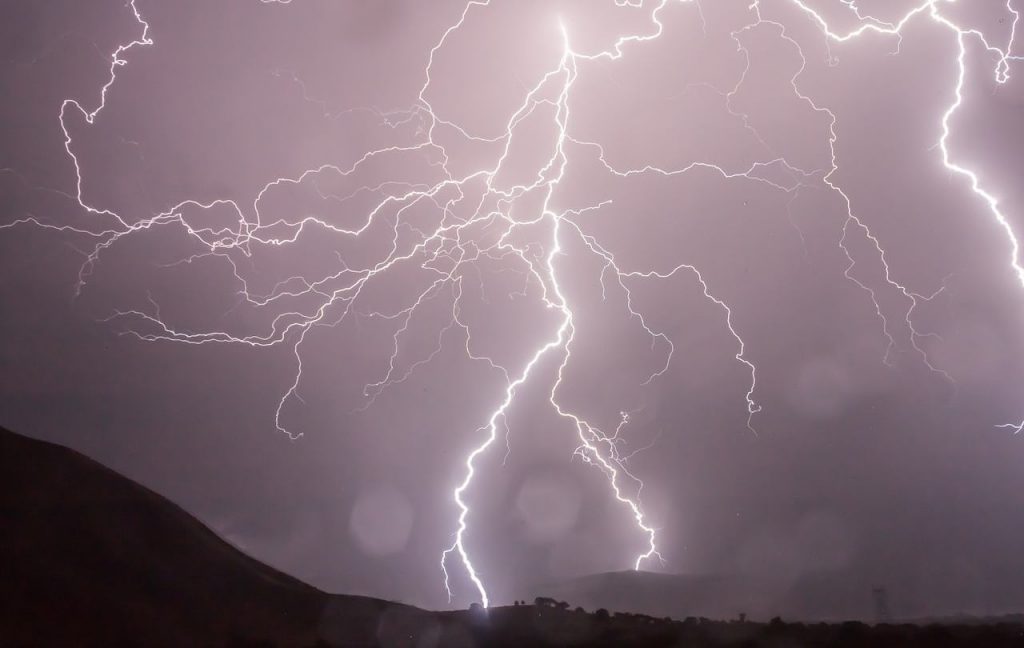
[8,0,1024,606]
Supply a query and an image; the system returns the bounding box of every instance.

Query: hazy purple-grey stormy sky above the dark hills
[0,0,1024,615]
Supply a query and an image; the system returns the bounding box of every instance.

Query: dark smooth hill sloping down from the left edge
[0,428,430,646]
